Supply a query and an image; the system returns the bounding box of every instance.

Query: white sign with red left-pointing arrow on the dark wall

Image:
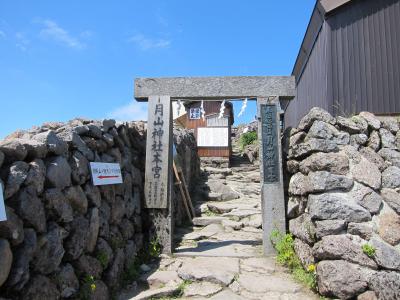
[90,162,122,185]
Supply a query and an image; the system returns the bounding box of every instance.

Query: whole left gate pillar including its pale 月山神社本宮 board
[144,96,173,254]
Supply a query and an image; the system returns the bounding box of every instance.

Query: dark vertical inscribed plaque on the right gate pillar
[261,104,280,184]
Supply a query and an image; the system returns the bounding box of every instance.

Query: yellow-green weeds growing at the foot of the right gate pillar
[270,230,317,290]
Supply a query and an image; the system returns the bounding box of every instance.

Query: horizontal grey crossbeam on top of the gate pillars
[135,76,296,101]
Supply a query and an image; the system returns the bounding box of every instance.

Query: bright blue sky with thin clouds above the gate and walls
[0,0,315,138]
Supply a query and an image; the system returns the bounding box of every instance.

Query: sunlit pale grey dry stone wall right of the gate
[286,108,400,299]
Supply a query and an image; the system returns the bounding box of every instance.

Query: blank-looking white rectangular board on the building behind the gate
[197,127,229,147]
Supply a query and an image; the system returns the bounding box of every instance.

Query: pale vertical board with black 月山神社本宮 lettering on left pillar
[145,96,171,208]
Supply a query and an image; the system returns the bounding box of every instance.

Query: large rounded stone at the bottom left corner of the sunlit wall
[317,260,368,299]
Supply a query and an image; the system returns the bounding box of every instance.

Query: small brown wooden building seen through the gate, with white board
[181,101,234,160]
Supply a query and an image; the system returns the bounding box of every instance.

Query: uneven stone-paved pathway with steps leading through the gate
[126,150,319,300]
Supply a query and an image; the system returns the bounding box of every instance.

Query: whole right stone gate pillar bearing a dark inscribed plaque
[257,97,286,255]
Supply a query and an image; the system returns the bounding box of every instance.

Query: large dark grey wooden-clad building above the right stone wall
[285,0,400,127]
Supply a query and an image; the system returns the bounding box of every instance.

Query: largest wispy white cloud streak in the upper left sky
[39,20,85,49]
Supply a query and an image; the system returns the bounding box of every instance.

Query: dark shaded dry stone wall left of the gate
[0,119,198,299]
